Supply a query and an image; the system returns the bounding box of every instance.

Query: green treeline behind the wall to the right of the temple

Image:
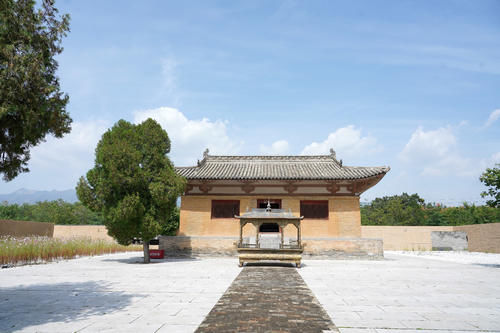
[361,193,500,226]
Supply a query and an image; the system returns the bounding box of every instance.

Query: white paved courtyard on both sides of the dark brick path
[0,252,500,333]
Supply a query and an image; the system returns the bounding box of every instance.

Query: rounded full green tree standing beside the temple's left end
[76,119,185,263]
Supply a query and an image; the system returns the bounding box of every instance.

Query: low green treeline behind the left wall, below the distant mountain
[0,200,103,224]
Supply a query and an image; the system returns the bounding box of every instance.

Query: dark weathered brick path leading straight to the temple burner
[196,265,338,333]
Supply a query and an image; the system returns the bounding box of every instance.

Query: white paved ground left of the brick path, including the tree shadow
[0,252,241,333]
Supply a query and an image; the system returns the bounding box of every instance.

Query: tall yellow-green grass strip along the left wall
[0,237,142,265]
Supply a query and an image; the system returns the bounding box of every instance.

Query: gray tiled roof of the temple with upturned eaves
[176,151,390,180]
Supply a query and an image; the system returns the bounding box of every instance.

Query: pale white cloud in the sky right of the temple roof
[399,127,478,176]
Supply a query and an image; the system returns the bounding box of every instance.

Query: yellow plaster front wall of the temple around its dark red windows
[178,196,361,237]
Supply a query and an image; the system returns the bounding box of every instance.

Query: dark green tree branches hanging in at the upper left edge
[0,0,71,181]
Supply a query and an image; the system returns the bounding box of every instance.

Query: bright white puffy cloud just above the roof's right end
[301,125,382,158]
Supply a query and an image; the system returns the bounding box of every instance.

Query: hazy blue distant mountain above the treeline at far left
[0,188,78,204]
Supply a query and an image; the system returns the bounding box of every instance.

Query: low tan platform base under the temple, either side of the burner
[159,236,384,259]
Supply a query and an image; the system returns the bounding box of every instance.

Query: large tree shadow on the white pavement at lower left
[0,281,142,332]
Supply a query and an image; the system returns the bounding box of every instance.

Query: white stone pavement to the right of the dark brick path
[299,252,500,333]
